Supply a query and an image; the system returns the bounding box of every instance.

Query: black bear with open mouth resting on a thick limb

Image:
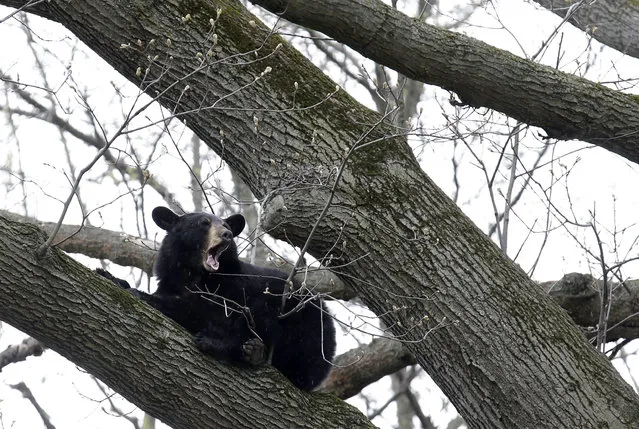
[98,207,335,390]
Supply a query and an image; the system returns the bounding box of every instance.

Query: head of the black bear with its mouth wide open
[152,207,246,288]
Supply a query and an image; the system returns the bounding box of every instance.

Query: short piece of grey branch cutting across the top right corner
[535,0,639,58]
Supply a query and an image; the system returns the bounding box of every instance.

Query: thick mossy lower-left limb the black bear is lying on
[0,215,372,429]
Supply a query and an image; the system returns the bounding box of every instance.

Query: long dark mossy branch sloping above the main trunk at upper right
[251,0,639,162]
